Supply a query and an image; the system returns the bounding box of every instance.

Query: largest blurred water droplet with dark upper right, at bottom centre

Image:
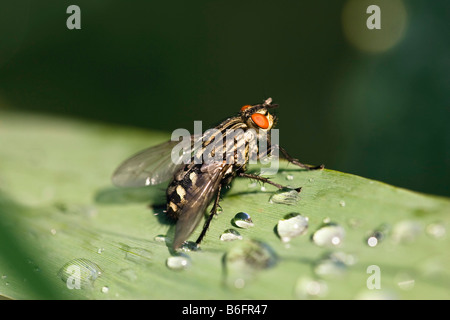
[224,240,277,289]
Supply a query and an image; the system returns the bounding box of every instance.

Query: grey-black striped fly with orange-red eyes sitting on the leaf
[112,98,324,249]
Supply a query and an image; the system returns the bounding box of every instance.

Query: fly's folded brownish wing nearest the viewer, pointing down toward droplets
[173,164,229,249]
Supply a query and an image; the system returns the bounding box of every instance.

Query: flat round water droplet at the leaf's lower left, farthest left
[58,258,102,289]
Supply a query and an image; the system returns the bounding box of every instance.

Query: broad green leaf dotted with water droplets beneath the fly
[0,111,450,299]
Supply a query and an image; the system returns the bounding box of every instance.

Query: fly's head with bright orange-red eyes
[240,98,278,132]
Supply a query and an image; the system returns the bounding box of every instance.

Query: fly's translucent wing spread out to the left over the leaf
[112,137,193,187]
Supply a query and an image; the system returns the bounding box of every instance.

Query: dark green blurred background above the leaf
[0,0,450,196]
